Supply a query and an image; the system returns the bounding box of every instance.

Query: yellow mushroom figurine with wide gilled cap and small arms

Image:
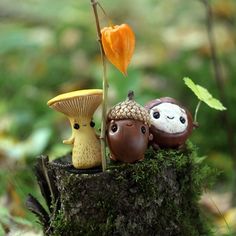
[47,89,103,169]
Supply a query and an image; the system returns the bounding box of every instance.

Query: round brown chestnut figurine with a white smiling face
[145,97,197,149]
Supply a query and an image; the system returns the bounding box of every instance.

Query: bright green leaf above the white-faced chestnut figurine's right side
[184,77,226,111]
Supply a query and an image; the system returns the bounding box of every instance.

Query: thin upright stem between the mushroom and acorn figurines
[91,0,108,171]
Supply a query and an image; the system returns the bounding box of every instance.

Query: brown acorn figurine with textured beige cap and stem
[107,92,151,163]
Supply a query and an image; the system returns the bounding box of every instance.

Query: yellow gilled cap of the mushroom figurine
[47,89,103,117]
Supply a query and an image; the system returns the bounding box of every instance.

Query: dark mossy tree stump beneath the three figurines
[27,143,211,236]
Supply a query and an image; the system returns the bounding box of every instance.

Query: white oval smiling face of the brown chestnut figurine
[150,102,188,134]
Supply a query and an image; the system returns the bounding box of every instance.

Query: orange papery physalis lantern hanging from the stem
[101,24,135,75]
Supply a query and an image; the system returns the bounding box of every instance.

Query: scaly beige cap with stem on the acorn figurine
[107,91,151,126]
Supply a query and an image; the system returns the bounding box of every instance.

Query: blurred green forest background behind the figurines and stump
[0,0,236,235]
